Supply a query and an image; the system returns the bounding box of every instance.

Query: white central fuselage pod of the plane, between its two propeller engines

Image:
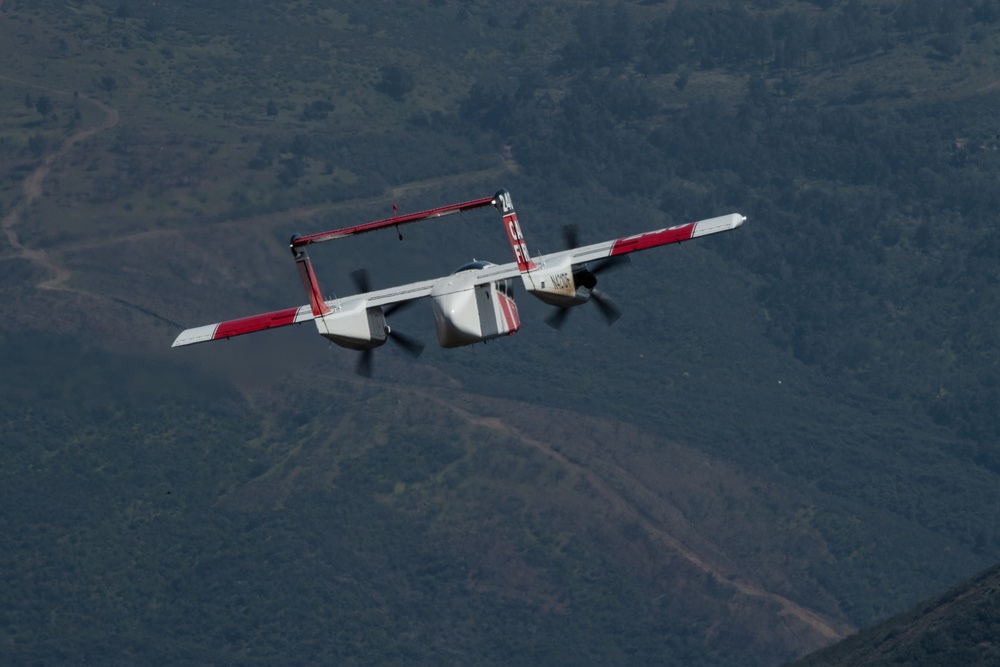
[431,273,521,347]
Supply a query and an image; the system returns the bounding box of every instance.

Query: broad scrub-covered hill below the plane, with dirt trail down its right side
[2,337,848,664]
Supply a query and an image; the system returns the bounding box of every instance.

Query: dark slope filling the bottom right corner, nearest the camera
[794,568,1000,667]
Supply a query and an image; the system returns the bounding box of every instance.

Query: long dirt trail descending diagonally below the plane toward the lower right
[425,395,854,641]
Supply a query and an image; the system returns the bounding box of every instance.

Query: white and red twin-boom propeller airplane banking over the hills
[172,190,746,377]
